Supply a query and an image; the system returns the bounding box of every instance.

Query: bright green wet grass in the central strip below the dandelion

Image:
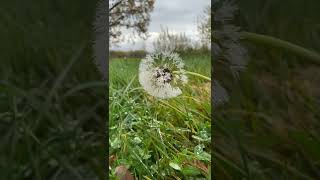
[109,55,211,179]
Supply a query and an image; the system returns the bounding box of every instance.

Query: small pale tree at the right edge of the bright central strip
[198,6,211,47]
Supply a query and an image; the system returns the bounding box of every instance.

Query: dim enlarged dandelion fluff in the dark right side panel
[212,0,248,105]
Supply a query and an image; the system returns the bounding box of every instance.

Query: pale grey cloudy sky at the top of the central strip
[110,0,211,51]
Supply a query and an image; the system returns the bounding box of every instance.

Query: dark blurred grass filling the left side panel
[0,0,107,180]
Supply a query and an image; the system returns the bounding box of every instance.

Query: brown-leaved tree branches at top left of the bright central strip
[109,0,155,43]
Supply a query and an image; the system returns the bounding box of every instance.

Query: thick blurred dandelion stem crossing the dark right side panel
[241,32,320,65]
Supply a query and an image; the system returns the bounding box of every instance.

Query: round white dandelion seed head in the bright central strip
[139,52,188,99]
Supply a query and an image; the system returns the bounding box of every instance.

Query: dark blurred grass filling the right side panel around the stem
[213,0,320,179]
